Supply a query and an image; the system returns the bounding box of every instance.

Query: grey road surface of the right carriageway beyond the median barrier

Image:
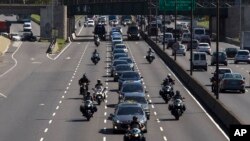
[152,35,250,124]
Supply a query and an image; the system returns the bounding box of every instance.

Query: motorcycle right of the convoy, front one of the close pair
[168,99,186,120]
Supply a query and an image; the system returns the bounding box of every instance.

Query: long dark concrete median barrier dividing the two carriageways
[141,33,241,133]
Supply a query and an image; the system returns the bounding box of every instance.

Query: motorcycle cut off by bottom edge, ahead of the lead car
[123,128,146,141]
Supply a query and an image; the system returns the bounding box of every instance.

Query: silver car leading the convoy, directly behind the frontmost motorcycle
[110,102,147,133]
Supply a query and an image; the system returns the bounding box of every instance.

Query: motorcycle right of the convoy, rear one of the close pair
[159,85,174,103]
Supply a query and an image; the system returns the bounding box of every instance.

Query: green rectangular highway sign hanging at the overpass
[159,0,195,11]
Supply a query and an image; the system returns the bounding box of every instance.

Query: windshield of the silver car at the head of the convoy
[117,107,143,115]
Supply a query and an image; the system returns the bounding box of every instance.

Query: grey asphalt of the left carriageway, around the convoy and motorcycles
[0,17,228,141]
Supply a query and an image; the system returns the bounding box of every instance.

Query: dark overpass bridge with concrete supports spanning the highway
[0,0,250,38]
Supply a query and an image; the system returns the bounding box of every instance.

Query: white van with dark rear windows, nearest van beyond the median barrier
[192,52,207,71]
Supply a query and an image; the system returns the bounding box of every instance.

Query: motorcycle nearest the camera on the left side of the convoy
[80,100,97,121]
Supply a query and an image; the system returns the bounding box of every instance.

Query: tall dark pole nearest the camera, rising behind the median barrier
[215,0,220,99]
